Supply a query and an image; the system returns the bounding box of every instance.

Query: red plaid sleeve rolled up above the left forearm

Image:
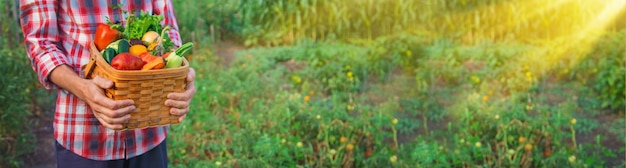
[20,0,67,89]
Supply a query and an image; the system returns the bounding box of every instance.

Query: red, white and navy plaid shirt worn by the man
[20,0,180,160]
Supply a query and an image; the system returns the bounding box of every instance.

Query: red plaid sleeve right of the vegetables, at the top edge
[155,0,182,46]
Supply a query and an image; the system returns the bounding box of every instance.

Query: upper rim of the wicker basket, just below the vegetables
[89,42,189,80]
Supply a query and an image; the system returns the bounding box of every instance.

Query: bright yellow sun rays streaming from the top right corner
[444,0,626,115]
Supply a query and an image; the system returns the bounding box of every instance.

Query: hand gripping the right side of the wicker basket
[165,68,196,122]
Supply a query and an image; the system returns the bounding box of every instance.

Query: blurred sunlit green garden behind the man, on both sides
[0,0,626,167]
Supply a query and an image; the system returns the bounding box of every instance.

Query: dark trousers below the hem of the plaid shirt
[55,139,167,168]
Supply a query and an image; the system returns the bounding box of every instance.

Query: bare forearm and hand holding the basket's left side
[49,65,135,129]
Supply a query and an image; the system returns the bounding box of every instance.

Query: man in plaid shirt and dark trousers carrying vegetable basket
[20,0,196,168]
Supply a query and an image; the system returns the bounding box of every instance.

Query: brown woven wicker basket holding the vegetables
[82,43,189,130]
